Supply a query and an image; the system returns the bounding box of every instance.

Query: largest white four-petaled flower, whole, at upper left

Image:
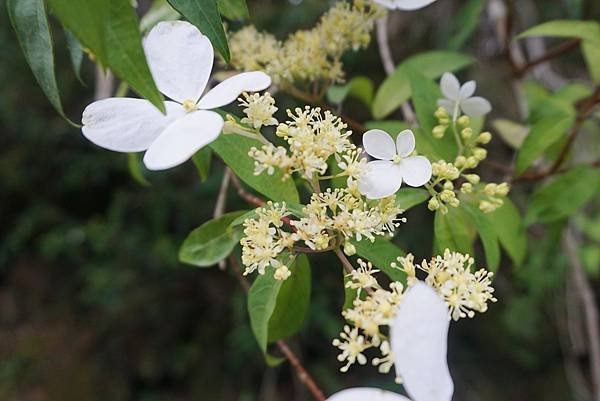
[82,21,271,170]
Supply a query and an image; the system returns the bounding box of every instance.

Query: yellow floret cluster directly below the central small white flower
[291,188,404,250]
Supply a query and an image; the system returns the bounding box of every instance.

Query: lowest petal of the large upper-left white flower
[144,110,224,170]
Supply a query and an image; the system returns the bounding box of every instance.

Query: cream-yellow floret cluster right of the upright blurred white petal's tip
[392,249,496,320]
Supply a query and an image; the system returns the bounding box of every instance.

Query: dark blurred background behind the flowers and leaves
[0,0,600,401]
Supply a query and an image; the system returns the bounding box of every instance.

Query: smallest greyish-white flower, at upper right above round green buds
[438,72,492,118]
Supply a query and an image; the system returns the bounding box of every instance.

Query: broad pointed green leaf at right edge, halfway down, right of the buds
[525,166,600,226]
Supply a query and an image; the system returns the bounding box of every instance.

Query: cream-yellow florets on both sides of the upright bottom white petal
[333,250,496,373]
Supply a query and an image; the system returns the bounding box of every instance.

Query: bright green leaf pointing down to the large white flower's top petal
[48,0,165,112]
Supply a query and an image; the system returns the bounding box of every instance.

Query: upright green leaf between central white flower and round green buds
[406,67,458,160]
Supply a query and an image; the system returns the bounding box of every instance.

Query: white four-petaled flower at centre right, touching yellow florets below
[358,129,431,199]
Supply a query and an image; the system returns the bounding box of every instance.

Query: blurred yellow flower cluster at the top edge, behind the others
[229,0,384,86]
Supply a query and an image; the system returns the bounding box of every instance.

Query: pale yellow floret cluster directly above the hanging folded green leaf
[240,202,294,280]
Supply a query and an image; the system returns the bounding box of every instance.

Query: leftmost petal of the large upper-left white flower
[81,97,185,152]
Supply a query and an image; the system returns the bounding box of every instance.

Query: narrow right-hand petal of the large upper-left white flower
[198,71,271,110]
